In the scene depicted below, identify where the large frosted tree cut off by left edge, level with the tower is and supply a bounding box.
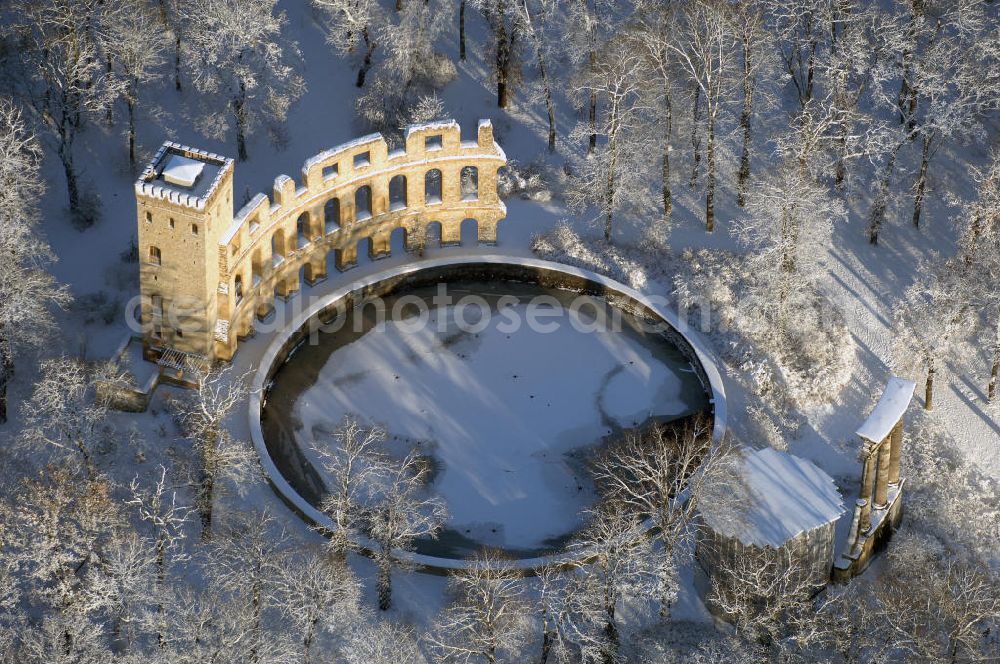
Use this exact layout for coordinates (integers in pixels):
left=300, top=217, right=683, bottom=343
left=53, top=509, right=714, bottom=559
left=0, top=99, right=70, bottom=424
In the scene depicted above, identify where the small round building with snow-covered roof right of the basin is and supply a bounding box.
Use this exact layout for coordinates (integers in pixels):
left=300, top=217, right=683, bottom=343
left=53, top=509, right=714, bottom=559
left=695, top=448, right=845, bottom=588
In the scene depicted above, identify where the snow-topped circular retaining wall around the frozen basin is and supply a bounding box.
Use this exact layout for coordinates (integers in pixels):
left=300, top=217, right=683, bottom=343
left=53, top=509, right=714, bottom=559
left=248, top=255, right=726, bottom=572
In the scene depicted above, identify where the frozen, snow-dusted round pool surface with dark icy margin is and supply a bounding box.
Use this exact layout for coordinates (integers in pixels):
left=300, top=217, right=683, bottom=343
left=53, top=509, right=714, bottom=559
left=260, top=274, right=710, bottom=558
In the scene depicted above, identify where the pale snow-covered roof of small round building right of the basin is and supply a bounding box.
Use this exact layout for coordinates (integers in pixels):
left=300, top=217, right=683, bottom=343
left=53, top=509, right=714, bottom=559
left=699, top=448, right=844, bottom=548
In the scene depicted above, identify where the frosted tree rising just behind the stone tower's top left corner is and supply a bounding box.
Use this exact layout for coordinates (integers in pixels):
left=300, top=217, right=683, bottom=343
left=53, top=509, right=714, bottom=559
left=102, top=0, right=167, bottom=168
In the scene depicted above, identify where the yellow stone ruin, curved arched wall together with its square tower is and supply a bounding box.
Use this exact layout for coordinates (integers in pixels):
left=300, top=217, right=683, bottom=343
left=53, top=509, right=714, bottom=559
left=135, top=120, right=506, bottom=362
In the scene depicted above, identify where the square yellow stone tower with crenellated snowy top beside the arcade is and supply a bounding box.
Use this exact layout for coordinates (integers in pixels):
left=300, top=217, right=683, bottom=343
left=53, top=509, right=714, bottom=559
left=135, top=142, right=233, bottom=371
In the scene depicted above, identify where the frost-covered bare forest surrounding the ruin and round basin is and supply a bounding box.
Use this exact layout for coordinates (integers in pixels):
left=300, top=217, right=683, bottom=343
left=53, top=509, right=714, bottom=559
left=0, top=0, right=1000, bottom=664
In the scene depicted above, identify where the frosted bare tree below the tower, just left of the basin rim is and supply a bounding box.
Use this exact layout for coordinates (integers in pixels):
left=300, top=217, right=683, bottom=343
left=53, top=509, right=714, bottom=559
left=174, top=367, right=257, bottom=540
